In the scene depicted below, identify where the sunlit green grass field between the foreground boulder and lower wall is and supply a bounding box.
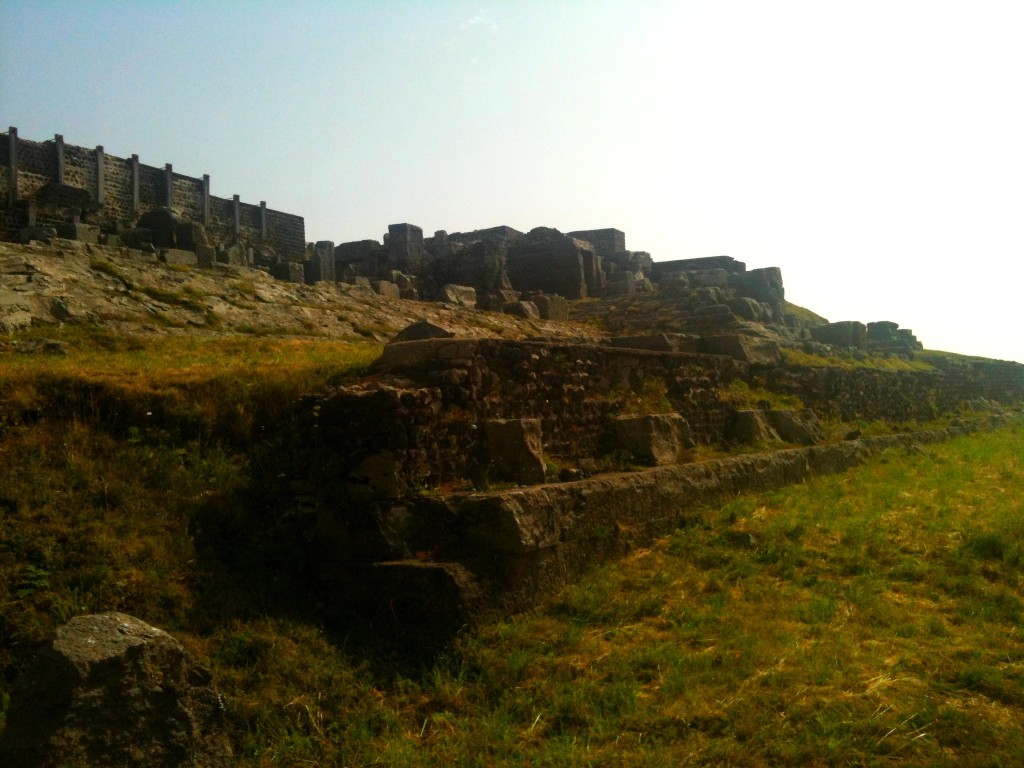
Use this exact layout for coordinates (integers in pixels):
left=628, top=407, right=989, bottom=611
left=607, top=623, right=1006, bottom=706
left=193, top=425, right=1024, bottom=766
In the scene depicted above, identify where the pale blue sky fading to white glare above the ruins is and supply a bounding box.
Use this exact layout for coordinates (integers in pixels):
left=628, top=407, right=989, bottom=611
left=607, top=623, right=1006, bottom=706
left=0, top=0, right=1024, bottom=361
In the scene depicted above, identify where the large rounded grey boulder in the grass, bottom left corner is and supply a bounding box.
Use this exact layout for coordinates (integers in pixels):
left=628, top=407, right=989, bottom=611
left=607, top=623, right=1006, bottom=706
left=0, top=613, right=231, bottom=768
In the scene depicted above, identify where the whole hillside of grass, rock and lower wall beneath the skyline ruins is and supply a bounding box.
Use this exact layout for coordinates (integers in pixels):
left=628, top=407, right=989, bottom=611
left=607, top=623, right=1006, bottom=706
left=0, top=240, right=1024, bottom=766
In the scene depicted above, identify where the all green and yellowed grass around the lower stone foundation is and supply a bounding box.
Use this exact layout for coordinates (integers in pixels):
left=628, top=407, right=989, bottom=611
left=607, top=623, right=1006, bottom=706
left=0, top=333, right=1024, bottom=766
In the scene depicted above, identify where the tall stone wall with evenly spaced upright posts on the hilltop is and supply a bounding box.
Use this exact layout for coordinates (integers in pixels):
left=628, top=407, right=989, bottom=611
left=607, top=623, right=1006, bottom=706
left=0, top=128, right=305, bottom=261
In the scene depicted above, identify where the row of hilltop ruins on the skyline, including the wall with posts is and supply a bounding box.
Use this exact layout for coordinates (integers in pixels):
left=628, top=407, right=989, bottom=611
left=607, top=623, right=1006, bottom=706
left=0, top=127, right=933, bottom=361
